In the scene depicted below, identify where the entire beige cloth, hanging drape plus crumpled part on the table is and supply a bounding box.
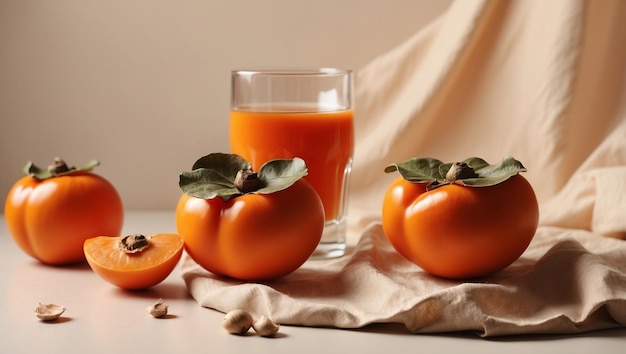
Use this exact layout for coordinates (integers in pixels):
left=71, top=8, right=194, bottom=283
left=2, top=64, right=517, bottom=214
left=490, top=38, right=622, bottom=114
left=181, top=0, right=626, bottom=336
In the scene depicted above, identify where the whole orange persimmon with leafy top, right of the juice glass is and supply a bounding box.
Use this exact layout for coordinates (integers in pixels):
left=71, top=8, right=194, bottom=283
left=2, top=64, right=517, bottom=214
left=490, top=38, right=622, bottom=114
left=382, top=157, right=539, bottom=279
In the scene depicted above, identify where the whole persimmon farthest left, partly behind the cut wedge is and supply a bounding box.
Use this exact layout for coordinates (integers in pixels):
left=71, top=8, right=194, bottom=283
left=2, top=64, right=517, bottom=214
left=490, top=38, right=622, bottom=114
left=4, top=158, right=124, bottom=265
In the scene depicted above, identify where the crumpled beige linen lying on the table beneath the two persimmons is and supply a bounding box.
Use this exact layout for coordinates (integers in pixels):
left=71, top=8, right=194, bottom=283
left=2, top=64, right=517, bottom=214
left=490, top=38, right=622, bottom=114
left=182, top=223, right=626, bottom=337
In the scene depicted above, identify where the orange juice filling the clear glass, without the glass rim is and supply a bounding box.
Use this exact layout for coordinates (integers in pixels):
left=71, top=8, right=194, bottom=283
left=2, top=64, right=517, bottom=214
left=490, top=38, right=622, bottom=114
left=230, top=110, right=354, bottom=220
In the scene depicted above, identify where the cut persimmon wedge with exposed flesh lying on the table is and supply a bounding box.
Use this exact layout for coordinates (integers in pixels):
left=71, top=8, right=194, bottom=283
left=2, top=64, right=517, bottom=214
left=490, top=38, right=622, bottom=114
left=83, top=234, right=183, bottom=290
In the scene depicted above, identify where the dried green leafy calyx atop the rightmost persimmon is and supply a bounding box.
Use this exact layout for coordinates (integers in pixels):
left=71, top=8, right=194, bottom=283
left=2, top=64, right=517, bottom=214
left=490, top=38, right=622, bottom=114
left=385, top=156, right=526, bottom=190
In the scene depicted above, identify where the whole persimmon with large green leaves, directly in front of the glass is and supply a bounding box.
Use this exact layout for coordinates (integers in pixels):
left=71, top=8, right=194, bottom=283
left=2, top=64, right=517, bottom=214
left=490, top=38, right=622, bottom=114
left=176, top=153, right=324, bottom=281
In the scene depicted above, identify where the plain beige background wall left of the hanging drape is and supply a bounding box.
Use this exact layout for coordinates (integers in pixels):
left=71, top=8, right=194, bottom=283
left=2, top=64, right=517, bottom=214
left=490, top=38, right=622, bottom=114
left=0, top=0, right=450, bottom=210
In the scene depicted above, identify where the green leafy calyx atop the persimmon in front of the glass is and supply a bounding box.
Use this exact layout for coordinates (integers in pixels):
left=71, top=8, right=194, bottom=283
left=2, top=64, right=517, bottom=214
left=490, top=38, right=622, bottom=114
left=178, top=153, right=308, bottom=201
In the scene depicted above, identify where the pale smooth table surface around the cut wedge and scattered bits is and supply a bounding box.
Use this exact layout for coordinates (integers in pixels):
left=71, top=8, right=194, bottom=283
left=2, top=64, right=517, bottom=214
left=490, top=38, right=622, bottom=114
left=0, top=211, right=626, bottom=354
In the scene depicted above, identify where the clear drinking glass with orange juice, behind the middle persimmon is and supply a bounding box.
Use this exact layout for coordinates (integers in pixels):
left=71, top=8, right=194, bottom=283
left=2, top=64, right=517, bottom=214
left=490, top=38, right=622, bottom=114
left=230, top=68, right=354, bottom=259
